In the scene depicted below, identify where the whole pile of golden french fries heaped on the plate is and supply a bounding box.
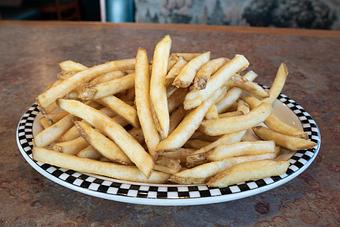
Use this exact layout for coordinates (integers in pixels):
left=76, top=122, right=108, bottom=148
left=33, top=35, right=316, bottom=187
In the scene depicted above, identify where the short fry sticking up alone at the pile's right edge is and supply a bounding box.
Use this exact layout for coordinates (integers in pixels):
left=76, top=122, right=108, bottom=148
left=268, top=63, right=288, bottom=103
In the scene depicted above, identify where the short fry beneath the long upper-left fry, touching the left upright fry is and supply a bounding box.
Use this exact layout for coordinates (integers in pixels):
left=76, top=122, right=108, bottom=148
left=79, top=73, right=135, bottom=100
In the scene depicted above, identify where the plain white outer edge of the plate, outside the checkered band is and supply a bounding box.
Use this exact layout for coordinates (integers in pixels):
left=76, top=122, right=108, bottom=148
left=16, top=94, right=321, bottom=206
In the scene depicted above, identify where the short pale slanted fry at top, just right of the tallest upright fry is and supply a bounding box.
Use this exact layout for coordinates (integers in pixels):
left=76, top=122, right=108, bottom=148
left=172, top=51, right=210, bottom=88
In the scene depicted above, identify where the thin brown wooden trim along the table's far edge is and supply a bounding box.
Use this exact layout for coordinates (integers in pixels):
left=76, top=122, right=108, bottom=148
left=0, top=20, right=340, bottom=38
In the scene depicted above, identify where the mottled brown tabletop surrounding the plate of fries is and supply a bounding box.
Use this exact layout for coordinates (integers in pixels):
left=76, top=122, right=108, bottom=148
left=0, top=21, right=340, bottom=226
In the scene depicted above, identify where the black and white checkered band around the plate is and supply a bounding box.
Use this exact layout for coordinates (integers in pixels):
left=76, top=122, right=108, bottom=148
left=17, top=94, right=320, bottom=199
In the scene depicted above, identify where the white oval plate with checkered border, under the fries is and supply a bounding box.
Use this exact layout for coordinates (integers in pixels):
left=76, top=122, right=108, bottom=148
left=16, top=94, right=321, bottom=206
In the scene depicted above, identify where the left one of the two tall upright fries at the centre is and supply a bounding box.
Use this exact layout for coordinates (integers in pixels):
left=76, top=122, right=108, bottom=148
left=135, top=48, right=160, bottom=154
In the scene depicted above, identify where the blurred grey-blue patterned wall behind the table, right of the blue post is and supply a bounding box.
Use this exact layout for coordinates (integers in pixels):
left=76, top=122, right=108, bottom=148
left=135, top=0, right=340, bottom=29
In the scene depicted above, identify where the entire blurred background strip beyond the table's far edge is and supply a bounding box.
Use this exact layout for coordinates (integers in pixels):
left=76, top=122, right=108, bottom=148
left=0, top=0, right=340, bottom=29
